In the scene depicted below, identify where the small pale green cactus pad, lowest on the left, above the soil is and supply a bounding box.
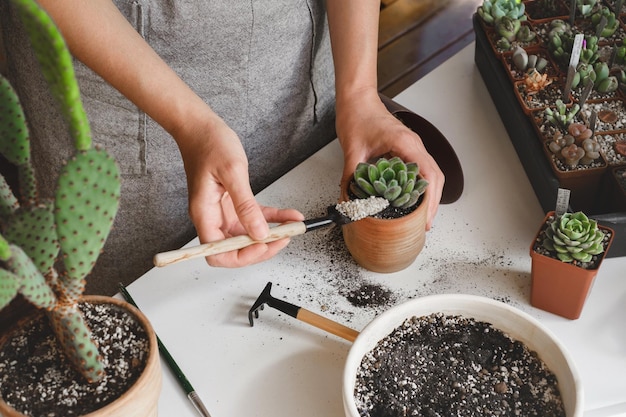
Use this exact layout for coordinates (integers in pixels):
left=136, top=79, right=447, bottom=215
left=7, top=245, right=56, bottom=309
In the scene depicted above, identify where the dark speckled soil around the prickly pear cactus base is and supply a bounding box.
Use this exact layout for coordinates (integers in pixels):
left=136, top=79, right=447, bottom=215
left=0, top=303, right=148, bottom=417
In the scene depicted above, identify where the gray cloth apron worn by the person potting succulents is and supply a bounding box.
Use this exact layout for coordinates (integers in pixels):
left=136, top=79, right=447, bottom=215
left=0, top=0, right=335, bottom=294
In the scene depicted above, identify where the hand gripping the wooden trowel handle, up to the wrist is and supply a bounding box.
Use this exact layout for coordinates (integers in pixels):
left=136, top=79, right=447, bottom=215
left=176, top=116, right=304, bottom=267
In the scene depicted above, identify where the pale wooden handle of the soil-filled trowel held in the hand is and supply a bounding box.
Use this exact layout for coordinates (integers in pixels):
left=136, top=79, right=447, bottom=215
left=153, top=222, right=307, bottom=266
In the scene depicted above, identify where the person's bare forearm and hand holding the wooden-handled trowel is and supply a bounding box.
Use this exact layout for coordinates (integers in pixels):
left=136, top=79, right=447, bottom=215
left=39, top=0, right=302, bottom=267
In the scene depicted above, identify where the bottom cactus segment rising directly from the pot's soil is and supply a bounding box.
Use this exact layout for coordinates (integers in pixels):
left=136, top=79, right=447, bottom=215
left=48, top=304, right=104, bottom=382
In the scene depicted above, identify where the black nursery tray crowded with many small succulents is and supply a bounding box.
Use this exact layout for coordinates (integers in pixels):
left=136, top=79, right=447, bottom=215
left=473, top=0, right=626, bottom=257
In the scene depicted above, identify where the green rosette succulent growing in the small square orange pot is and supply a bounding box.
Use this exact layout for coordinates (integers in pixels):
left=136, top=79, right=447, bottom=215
left=542, top=211, right=604, bottom=262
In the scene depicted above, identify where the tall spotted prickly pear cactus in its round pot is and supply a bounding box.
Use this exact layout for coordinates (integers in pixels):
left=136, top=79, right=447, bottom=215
left=0, top=0, right=161, bottom=416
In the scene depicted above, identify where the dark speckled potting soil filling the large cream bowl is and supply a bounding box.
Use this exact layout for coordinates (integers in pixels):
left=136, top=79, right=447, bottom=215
left=354, top=313, right=565, bottom=417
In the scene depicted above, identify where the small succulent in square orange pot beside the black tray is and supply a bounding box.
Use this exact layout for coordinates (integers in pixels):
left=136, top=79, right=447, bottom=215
left=530, top=211, right=615, bottom=320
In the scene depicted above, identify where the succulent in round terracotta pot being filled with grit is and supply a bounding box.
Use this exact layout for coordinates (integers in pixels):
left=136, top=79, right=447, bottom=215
left=341, top=157, right=428, bottom=273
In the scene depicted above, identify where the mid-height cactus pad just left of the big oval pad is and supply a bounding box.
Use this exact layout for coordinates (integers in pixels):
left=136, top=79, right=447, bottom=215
left=5, top=203, right=59, bottom=274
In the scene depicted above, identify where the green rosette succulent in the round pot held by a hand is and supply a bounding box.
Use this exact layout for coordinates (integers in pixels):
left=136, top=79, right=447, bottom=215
left=350, top=156, right=428, bottom=208
